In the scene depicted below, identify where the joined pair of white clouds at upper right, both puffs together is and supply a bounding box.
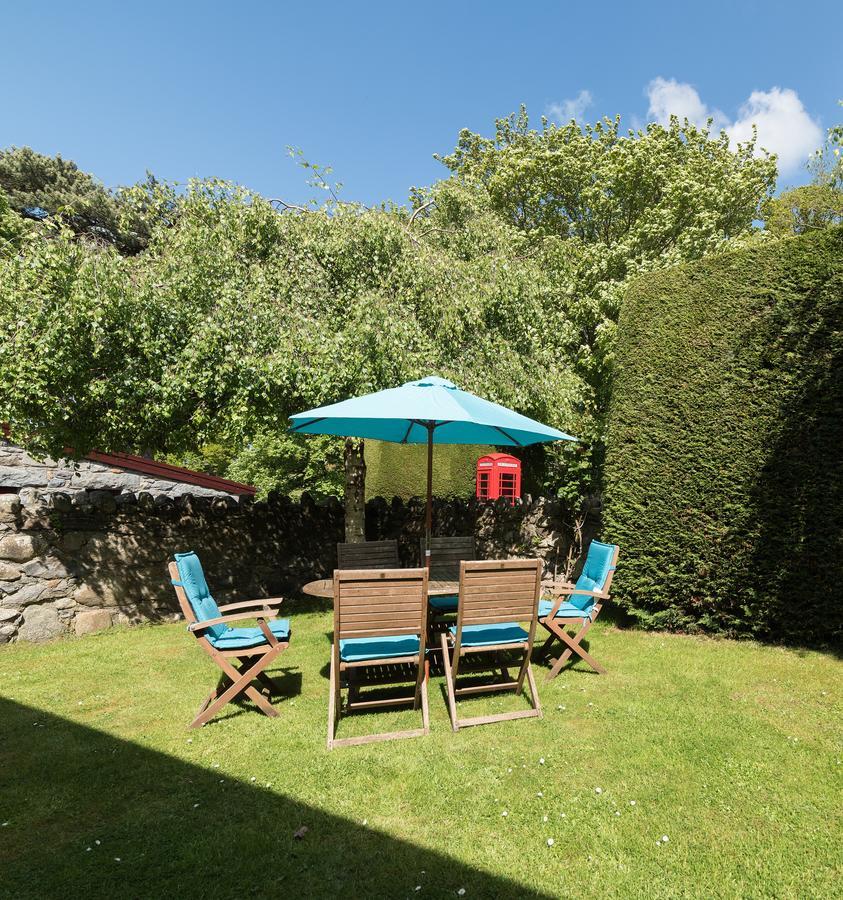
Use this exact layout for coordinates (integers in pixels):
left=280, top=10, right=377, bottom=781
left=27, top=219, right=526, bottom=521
left=646, top=78, right=823, bottom=173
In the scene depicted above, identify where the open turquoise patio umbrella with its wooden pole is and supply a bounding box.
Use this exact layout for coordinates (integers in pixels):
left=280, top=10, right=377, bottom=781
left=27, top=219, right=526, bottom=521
left=290, top=375, right=577, bottom=566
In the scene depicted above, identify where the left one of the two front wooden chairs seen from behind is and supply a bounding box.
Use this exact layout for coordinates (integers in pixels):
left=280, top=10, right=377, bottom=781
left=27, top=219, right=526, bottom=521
left=328, top=569, right=430, bottom=750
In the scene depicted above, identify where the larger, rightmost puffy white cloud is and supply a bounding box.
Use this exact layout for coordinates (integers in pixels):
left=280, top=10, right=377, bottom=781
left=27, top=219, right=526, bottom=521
left=726, top=88, right=823, bottom=172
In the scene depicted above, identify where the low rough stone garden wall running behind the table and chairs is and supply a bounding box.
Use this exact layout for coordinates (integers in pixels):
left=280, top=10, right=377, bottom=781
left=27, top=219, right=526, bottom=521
left=0, top=491, right=592, bottom=643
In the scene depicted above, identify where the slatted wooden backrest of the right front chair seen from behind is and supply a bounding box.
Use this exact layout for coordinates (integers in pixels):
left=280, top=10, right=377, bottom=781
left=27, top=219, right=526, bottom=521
left=457, top=559, right=541, bottom=630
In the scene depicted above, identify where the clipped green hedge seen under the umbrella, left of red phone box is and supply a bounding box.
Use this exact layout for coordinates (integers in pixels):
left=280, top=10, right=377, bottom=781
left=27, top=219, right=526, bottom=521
left=365, top=441, right=494, bottom=500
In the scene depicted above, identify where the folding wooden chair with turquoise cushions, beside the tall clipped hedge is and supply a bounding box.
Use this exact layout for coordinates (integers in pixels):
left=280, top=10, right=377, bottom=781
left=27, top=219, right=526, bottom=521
left=539, top=541, right=620, bottom=681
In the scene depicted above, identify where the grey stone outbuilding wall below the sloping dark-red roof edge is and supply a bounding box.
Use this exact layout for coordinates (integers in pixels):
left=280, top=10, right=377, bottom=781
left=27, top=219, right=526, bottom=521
left=0, top=440, right=244, bottom=497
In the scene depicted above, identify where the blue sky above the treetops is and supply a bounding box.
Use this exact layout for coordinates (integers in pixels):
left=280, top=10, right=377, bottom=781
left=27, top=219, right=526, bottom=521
left=0, top=0, right=843, bottom=204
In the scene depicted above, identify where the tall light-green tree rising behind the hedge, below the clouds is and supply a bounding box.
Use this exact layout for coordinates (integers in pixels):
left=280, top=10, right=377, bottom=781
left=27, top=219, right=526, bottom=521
left=441, top=107, right=776, bottom=430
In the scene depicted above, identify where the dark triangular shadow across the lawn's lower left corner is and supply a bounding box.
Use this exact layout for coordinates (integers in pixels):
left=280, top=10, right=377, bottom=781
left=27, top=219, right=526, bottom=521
left=0, top=699, right=545, bottom=898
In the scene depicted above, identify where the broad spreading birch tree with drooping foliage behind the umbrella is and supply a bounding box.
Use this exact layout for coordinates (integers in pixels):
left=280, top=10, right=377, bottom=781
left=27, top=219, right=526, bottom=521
left=0, top=181, right=581, bottom=536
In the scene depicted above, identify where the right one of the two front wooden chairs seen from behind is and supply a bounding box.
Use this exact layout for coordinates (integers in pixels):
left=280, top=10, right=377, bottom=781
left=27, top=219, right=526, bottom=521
left=441, top=559, right=542, bottom=731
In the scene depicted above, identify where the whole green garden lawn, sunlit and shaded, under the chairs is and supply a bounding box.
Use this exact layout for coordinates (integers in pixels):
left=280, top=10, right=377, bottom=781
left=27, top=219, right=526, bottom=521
left=0, top=602, right=843, bottom=898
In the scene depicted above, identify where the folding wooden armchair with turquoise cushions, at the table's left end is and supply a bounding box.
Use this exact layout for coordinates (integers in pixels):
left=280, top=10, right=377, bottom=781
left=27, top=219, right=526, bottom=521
left=168, top=553, right=290, bottom=728
